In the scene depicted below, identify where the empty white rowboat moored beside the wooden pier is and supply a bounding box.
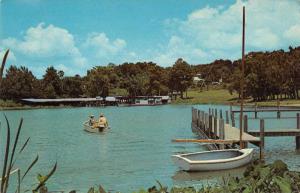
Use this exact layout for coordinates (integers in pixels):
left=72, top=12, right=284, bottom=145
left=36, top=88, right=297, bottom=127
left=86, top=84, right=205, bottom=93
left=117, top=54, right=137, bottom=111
left=172, top=148, right=253, bottom=171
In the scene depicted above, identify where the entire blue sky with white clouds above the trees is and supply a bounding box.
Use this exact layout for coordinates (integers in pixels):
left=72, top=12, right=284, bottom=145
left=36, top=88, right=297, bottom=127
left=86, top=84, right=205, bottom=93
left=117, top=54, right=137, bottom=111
left=0, top=0, right=300, bottom=77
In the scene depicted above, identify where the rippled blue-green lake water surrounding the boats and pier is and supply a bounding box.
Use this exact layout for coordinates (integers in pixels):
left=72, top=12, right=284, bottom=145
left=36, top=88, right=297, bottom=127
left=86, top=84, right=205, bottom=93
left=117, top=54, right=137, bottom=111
left=0, top=105, right=300, bottom=192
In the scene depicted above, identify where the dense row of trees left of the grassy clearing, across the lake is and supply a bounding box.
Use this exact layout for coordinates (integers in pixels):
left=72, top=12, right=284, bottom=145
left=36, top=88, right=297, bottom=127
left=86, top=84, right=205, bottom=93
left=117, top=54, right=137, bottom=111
left=0, top=59, right=192, bottom=100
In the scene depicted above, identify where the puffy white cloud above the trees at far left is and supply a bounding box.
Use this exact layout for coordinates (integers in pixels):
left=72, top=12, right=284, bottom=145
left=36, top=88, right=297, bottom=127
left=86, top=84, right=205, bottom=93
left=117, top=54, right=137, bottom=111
left=1, top=23, right=87, bottom=76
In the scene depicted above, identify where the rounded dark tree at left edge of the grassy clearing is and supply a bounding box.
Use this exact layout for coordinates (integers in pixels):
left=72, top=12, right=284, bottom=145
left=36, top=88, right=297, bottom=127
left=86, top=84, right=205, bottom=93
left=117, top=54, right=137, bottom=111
left=169, top=58, right=193, bottom=98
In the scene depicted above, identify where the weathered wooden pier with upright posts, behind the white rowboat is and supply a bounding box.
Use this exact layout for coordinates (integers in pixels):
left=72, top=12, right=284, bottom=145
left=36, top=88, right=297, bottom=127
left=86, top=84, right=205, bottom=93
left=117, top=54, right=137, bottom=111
left=191, top=108, right=300, bottom=159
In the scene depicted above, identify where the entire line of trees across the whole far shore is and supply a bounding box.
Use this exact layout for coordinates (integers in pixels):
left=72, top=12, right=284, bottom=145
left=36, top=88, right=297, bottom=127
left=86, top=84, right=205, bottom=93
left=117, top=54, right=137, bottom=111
left=0, top=47, right=300, bottom=101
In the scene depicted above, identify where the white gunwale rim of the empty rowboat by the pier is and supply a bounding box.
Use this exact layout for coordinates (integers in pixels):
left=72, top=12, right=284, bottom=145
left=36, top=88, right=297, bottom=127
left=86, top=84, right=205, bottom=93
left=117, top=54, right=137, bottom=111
left=172, top=148, right=254, bottom=164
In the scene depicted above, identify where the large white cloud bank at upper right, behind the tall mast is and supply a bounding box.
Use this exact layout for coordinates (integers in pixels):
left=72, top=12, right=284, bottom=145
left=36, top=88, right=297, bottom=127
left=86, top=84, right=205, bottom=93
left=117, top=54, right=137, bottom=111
left=154, top=0, right=300, bottom=65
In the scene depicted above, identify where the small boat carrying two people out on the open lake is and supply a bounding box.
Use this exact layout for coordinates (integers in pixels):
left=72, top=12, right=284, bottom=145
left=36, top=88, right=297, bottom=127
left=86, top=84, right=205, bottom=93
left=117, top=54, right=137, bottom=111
left=83, top=113, right=110, bottom=133
